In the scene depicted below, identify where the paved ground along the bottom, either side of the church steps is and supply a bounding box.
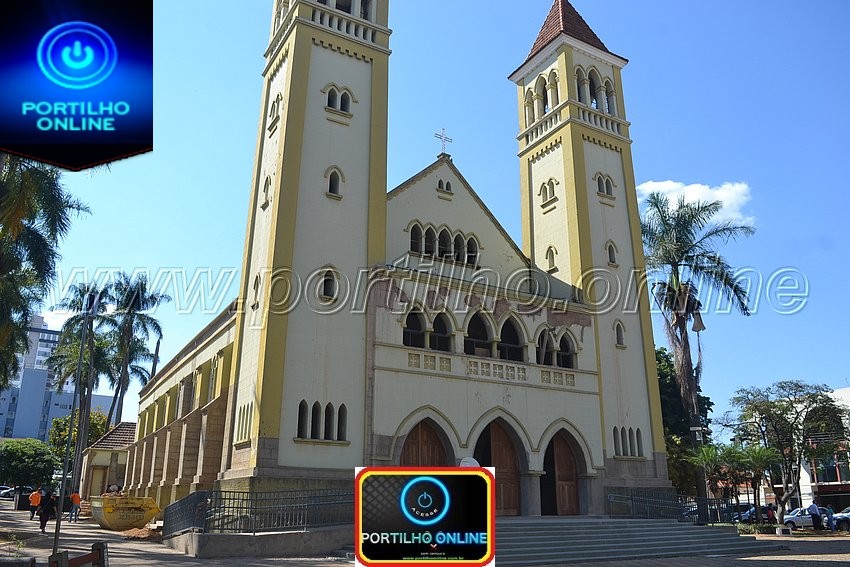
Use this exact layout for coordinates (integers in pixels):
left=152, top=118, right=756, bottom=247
left=0, top=500, right=850, bottom=567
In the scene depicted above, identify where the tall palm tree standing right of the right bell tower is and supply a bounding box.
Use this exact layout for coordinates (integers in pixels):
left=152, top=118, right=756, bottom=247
left=641, top=193, right=755, bottom=492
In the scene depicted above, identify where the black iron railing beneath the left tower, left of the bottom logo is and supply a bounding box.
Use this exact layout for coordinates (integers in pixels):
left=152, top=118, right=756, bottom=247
left=162, top=490, right=354, bottom=537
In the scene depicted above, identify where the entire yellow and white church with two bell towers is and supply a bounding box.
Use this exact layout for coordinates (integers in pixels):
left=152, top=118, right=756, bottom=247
left=125, top=0, right=670, bottom=515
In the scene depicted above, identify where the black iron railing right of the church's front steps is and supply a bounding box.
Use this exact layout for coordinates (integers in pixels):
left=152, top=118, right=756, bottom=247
left=608, top=489, right=734, bottom=524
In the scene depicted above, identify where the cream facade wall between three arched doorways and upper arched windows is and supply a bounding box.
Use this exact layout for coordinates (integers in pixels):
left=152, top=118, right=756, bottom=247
left=373, top=347, right=603, bottom=473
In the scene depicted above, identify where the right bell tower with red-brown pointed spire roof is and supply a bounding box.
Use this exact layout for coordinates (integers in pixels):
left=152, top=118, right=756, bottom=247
left=510, top=0, right=669, bottom=486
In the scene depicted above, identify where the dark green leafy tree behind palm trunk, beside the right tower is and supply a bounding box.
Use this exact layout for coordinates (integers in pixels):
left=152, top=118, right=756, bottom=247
left=655, top=347, right=714, bottom=495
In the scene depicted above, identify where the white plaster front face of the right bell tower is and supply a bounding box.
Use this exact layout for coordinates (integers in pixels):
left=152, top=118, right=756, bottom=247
left=584, top=142, right=652, bottom=456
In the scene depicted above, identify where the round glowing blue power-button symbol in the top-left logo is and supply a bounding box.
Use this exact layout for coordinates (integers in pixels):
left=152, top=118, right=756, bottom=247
left=37, top=22, right=118, bottom=90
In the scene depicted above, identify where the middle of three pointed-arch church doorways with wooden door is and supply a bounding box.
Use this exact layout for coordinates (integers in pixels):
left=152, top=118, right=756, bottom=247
left=474, top=420, right=520, bottom=516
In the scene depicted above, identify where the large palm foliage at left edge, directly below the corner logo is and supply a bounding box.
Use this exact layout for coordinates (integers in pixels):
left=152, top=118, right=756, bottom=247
left=0, top=153, right=88, bottom=388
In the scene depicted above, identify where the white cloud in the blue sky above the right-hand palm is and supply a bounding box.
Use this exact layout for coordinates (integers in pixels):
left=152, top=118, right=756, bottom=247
left=637, top=180, right=756, bottom=225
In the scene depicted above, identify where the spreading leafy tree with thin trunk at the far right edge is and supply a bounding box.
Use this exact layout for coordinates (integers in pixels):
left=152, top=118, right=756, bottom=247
left=730, top=380, right=847, bottom=523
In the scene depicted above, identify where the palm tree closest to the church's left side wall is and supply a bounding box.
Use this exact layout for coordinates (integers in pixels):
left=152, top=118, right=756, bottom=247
left=105, top=273, right=171, bottom=424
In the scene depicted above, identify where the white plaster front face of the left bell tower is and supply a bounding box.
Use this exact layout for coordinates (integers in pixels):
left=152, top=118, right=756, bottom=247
left=278, top=45, right=372, bottom=469
